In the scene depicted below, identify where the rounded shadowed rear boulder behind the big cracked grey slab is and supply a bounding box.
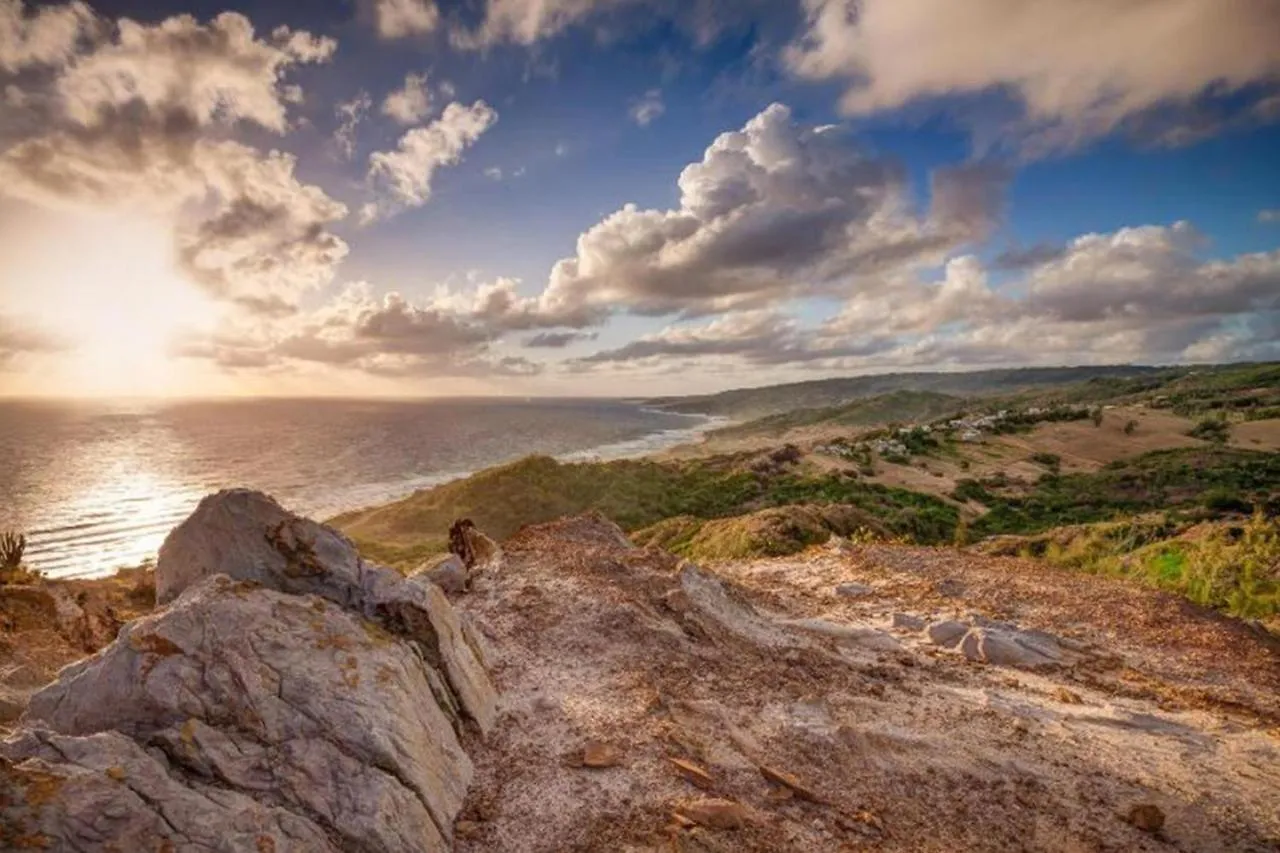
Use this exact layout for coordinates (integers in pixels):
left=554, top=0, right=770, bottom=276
left=156, top=489, right=497, bottom=731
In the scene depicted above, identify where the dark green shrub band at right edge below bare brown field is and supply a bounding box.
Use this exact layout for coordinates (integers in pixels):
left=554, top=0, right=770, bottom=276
left=952, top=447, right=1280, bottom=535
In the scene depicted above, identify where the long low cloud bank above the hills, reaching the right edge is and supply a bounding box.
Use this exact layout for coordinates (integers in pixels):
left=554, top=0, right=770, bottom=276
left=568, top=223, right=1280, bottom=371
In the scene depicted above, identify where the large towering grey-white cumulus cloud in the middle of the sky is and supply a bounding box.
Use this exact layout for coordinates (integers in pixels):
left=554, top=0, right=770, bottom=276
left=543, top=104, right=1007, bottom=315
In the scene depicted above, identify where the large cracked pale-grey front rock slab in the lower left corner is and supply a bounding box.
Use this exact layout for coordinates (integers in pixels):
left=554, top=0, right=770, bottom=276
left=0, top=576, right=472, bottom=852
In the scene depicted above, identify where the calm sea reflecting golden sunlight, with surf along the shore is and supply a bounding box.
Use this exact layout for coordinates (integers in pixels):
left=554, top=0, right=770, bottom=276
left=0, top=398, right=712, bottom=578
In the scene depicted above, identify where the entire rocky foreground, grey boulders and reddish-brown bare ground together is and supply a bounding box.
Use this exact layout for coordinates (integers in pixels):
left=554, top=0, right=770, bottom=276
left=0, top=492, right=1280, bottom=852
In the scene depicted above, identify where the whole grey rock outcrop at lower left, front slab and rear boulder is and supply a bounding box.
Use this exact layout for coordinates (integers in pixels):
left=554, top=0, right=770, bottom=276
left=0, top=491, right=497, bottom=852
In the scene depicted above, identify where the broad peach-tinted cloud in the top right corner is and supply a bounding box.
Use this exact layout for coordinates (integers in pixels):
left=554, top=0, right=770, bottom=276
left=785, top=0, right=1280, bottom=150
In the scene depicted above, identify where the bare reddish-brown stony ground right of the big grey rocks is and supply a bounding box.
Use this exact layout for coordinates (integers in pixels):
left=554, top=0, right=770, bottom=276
left=456, top=519, right=1280, bottom=853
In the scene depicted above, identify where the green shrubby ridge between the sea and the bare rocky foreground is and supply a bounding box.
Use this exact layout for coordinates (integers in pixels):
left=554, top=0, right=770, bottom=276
left=333, top=455, right=957, bottom=566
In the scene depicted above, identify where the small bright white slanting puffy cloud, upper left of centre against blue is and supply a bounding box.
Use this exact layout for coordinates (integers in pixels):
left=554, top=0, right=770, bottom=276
left=361, top=101, right=498, bottom=223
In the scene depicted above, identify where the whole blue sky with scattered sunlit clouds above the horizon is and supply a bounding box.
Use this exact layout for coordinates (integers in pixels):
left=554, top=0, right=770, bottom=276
left=0, top=0, right=1280, bottom=397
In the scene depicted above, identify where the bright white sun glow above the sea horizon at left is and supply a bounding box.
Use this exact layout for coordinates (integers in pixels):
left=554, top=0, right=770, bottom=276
left=27, top=218, right=215, bottom=396
